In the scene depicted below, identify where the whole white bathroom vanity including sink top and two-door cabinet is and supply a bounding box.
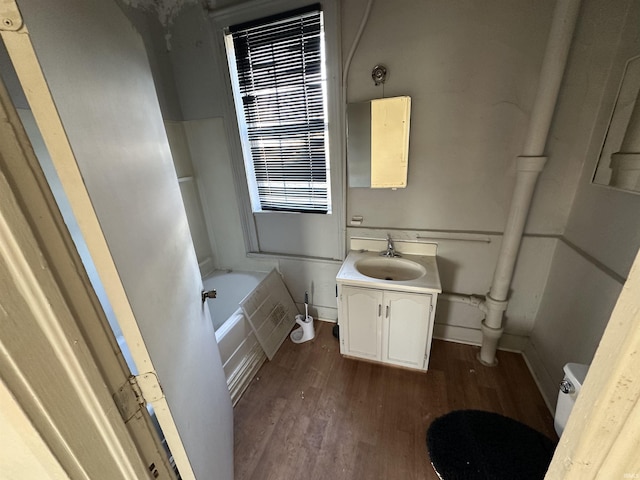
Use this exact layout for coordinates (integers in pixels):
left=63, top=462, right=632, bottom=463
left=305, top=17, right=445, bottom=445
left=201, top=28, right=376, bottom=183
left=336, top=246, right=442, bottom=371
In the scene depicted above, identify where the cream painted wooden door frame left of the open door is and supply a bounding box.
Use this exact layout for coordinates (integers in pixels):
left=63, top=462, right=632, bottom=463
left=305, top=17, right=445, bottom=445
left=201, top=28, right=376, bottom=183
left=0, top=66, right=175, bottom=479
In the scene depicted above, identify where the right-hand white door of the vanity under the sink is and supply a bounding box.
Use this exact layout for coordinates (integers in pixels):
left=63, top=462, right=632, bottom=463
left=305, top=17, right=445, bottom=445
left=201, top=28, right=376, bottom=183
left=382, top=292, right=432, bottom=370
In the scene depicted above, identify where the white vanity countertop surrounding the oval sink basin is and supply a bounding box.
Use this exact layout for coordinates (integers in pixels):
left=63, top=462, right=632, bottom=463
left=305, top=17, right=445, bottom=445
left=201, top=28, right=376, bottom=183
left=336, top=250, right=442, bottom=293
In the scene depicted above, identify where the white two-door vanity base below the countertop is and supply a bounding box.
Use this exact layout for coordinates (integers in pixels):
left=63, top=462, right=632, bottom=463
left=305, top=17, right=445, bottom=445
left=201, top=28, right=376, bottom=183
left=338, top=283, right=437, bottom=371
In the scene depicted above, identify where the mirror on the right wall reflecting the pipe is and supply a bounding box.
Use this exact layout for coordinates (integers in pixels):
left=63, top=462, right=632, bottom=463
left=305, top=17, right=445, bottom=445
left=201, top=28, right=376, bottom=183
left=593, top=55, right=640, bottom=193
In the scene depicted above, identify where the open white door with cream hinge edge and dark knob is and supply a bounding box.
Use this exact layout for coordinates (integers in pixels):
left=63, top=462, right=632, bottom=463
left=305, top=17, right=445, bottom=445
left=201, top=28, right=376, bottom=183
left=2, top=0, right=233, bottom=480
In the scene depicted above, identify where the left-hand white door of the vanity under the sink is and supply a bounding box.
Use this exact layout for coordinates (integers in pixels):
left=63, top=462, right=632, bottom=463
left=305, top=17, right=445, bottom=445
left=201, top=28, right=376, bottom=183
left=340, top=286, right=382, bottom=360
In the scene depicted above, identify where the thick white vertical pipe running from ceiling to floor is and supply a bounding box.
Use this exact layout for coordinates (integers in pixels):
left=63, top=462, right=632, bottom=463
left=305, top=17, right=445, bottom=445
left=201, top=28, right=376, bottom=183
left=479, top=0, right=580, bottom=365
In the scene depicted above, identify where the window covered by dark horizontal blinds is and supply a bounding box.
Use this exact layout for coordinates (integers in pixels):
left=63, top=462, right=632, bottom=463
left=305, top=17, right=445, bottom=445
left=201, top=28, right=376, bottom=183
left=225, top=5, right=331, bottom=213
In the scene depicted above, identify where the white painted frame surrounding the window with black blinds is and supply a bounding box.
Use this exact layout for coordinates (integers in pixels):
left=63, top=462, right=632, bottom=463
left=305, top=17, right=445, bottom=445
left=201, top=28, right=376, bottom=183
left=210, top=0, right=345, bottom=260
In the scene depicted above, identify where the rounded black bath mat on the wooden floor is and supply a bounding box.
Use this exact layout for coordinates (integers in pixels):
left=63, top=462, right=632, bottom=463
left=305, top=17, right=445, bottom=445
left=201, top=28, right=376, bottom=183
left=427, top=410, right=555, bottom=480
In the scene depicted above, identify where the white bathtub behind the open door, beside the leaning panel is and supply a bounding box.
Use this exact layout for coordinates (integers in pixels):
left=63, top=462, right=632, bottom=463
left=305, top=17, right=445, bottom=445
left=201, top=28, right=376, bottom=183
left=203, top=270, right=267, bottom=405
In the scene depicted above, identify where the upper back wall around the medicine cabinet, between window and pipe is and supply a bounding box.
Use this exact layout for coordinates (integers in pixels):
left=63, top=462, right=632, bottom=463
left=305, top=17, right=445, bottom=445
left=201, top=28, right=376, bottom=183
left=342, top=0, right=556, bottom=233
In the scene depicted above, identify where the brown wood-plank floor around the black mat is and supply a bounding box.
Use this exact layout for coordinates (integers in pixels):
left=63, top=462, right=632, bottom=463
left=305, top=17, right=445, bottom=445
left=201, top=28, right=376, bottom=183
left=234, top=322, right=557, bottom=480
